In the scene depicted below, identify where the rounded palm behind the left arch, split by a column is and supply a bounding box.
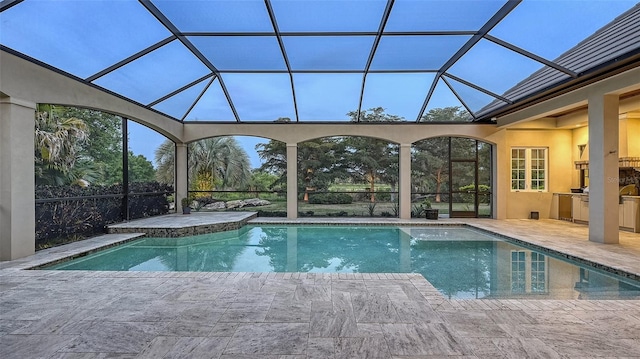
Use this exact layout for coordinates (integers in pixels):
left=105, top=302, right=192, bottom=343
left=155, top=137, right=251, bottom=191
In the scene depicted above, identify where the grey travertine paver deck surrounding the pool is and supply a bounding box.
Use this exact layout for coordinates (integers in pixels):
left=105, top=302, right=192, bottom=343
left=0, top=216, right=640, bottom=359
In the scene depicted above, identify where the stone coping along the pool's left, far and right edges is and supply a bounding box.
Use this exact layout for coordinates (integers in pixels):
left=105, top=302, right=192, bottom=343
left=6, top=217, right=640, bottom=282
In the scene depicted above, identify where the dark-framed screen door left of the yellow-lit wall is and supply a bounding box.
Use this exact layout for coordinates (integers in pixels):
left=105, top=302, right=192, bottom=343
left=449, top=160, right=478, bottom=218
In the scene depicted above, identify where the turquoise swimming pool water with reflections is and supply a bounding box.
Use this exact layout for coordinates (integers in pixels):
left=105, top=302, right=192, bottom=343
left=47, top=225, right=640, bottom=299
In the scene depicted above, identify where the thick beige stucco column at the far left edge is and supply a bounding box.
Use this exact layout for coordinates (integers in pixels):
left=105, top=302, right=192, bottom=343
left=0, top=95, right=36, bottom=260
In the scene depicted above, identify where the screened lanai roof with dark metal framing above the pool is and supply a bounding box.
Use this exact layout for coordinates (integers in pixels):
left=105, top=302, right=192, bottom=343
left=0, top=0, right=640, bottom=122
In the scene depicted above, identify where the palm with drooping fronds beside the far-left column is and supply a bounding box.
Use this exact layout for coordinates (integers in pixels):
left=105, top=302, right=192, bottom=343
left=34, top=105, right=96, bottom=185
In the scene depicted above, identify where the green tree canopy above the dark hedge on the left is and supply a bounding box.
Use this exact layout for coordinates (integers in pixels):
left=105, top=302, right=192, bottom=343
left=35, top=105, right=160, bottom=185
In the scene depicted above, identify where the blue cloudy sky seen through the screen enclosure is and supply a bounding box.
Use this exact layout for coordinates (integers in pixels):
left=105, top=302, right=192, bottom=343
left=0, top=0, right=638, bottom=167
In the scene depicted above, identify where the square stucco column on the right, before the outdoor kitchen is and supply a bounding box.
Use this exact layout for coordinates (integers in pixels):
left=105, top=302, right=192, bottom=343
left=588, top=94, right=619, bottom=243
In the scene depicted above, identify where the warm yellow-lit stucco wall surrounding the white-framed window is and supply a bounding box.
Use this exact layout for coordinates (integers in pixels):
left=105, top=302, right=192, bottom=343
left=498, top=130, right=574, bottom=218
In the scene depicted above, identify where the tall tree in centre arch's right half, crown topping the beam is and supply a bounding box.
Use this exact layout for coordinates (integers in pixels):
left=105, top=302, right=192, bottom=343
left=345, top=107, right=404, bottom=202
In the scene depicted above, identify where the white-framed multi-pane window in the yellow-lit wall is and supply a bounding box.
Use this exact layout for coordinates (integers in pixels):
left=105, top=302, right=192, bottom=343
left=511, top=148, right=547, bottom=192
